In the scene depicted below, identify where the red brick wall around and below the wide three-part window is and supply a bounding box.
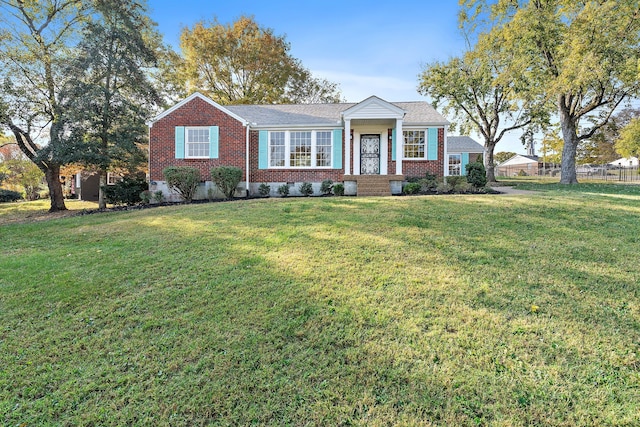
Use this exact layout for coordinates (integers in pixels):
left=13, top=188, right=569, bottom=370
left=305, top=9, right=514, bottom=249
left=249, top=130, right=344, bottom=183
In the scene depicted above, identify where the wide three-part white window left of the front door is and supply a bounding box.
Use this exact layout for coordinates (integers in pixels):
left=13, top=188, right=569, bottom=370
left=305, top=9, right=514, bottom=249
left=268, top=130, right=333, bottom=168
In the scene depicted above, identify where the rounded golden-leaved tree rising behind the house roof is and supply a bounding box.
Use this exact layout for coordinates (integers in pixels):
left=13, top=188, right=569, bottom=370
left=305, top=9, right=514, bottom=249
left=174, top=16, right=340, bottom=104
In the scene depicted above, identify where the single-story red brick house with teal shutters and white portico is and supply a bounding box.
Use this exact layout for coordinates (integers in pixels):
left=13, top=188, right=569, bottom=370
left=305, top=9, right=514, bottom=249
left=149, top=93, right=462, bottom=200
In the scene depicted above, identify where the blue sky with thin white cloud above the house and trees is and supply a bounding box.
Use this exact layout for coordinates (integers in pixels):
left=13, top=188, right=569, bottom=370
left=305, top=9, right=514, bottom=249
left=148, top=0, right=524, bottom=152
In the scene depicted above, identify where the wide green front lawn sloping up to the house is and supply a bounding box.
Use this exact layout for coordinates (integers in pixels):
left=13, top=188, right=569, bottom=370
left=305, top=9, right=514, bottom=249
left=0, top=191, right=640, bottom=426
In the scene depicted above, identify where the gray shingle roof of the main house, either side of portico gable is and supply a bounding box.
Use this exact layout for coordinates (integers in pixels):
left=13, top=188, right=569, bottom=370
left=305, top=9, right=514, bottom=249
left=225, top=101, right=448, bottom=126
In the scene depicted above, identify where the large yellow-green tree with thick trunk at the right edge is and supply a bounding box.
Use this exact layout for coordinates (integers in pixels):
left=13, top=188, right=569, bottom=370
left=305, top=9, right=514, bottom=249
left=463, top=0, right=640, bottom=184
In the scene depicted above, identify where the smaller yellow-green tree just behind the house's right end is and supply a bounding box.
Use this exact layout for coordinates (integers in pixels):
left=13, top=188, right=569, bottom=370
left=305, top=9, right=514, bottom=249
left=418, top=30, right=545, bottom=183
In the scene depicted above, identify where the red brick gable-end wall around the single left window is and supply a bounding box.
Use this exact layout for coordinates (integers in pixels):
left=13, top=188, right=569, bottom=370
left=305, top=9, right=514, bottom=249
left=149, top=98, right=246, bottom=181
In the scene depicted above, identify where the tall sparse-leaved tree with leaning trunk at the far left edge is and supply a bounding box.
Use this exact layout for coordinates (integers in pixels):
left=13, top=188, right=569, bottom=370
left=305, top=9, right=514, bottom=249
left=0, top=0, right=89, bottom=212
